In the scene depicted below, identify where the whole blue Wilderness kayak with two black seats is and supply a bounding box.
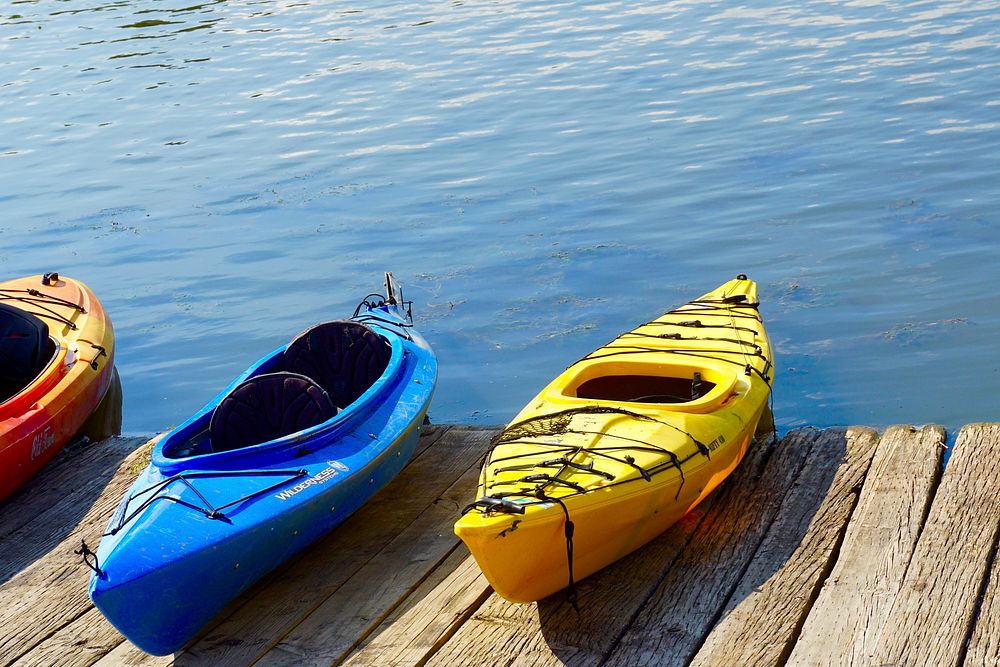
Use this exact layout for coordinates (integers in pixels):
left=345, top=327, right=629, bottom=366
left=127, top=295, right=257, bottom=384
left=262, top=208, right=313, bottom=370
left=89, top=274, right=437, bottom=655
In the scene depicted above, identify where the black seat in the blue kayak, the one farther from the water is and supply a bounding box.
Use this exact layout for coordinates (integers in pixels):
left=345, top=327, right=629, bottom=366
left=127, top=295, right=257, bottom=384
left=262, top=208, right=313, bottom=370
left=208, top=372, right=337, bottom=452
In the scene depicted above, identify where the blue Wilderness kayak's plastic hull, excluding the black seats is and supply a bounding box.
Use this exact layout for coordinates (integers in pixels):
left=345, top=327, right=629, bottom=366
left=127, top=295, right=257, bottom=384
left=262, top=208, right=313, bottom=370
left=90, top=306, right=437, bottom=655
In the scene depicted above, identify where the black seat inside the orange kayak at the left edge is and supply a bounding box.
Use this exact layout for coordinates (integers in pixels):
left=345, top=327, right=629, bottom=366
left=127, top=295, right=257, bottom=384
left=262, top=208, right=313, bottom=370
left=0, top=303, right=53, bottom=401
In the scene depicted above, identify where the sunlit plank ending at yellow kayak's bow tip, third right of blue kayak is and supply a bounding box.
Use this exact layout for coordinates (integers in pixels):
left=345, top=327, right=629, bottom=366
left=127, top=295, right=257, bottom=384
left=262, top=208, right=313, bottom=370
left=344, top=545, right=493, bottom=667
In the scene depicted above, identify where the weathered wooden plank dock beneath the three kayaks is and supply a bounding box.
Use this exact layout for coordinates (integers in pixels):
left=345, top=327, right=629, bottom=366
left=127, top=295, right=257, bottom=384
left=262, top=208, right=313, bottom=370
left=0, top=424, right=1000, bottom=667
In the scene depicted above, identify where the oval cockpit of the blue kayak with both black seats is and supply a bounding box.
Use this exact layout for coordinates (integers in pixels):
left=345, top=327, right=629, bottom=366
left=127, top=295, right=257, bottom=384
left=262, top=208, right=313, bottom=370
left=153, top=320, right=403, bottom=468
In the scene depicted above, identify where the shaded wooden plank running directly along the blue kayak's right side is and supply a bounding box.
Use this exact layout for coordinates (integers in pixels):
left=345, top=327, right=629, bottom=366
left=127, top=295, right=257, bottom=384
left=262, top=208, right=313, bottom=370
left=111, top=426, right=493, bottom=666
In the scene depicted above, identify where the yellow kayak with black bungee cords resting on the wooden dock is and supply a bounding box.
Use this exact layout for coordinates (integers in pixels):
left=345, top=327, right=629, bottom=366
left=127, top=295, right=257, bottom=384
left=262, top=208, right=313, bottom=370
left=455, top=275, right=774, bottom=602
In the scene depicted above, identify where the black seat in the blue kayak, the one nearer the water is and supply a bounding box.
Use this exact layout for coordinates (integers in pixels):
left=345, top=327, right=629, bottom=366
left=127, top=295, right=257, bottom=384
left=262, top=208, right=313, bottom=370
left=282, top=320, right=392, bottom=409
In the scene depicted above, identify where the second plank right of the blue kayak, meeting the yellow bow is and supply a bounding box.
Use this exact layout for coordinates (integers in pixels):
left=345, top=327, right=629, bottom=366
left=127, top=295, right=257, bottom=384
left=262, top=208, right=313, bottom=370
left=262, top=452, right=487, bottom=666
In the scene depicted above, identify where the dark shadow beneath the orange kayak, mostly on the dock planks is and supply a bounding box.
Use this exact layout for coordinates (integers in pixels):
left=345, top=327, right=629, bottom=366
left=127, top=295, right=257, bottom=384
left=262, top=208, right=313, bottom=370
left=0, top=368, right=129, bottom=584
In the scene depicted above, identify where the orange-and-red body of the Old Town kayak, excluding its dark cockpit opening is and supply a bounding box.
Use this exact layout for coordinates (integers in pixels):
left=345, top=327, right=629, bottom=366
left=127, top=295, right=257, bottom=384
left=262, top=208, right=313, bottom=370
left=0, top=276, right=115, bottom=501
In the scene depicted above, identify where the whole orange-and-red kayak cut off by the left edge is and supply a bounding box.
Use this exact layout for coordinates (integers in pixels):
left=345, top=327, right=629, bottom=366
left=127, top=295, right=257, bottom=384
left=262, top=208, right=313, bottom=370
left=0, top=274, right=114, bottom=500
